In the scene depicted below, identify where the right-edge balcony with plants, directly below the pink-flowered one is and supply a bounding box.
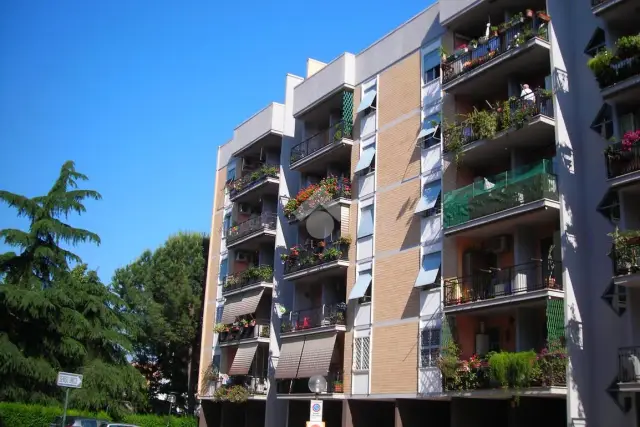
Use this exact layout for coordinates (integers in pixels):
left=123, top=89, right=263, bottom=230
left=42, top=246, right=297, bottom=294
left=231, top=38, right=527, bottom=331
left=610, top=229, right=640, bottom=287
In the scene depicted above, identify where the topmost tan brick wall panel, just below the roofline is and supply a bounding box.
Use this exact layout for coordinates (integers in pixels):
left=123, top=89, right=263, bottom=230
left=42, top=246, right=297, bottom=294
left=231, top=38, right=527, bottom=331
left=378, top=52, right=422, bottom=128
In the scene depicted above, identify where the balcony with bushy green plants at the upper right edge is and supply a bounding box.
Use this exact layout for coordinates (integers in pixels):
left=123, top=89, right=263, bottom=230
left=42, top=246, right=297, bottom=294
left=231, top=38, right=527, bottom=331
left=587, top=34, right=640, bottom=102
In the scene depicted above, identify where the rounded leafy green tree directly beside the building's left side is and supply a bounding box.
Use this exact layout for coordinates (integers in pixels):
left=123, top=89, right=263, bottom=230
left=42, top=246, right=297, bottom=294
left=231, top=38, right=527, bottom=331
left=111, top=233, right=209, bottom=413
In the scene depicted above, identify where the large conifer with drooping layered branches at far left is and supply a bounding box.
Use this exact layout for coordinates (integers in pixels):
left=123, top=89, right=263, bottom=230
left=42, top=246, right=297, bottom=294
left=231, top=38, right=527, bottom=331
left=0, top=162, right=146, bottom=418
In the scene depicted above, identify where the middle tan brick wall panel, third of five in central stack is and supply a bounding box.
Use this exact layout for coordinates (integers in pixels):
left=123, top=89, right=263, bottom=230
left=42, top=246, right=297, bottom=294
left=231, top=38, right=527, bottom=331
left=374, top=178, right=420, bottom=255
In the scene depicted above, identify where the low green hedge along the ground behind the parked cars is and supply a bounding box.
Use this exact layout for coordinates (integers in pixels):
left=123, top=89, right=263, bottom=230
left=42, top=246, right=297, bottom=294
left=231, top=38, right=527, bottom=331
left=0, top=402, right=198, bottom=427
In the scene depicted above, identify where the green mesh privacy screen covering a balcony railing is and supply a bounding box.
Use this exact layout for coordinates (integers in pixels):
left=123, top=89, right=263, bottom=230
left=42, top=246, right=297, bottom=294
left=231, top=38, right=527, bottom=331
left=443, top=159, right=558, bottom=228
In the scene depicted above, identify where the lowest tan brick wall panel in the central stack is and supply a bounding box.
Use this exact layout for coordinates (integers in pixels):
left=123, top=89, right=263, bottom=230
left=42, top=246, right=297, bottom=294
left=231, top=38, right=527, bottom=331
left=371, top=319, right=418, bottom=394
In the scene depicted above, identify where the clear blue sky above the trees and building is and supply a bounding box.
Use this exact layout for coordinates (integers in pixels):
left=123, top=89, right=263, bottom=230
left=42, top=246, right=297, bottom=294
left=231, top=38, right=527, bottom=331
left=0, top=0, right=431, bottom=281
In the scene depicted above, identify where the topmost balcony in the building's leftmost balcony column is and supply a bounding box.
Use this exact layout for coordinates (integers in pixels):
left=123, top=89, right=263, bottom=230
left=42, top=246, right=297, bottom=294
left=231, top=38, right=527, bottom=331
left=227, top=165, right=280, bottom=203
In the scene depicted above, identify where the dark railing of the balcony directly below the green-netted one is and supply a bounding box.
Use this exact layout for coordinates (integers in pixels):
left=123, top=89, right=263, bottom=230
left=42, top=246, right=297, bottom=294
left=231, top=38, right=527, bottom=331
left=444, top=260, right=563, bottom=306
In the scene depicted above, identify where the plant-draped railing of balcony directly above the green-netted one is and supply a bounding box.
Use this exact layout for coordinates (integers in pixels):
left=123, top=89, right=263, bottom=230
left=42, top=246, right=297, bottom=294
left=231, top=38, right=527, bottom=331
left=444, top=88, right=554, bottom=152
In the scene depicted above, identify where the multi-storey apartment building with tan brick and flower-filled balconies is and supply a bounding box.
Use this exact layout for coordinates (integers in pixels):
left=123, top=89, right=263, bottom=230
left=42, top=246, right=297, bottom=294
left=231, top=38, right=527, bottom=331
left=199, top=0, right=640, bottom=427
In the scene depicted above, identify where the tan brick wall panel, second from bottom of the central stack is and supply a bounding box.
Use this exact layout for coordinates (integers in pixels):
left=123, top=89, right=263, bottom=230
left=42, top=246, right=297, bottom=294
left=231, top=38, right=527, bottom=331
left=372, top=248, right=420, bottom=323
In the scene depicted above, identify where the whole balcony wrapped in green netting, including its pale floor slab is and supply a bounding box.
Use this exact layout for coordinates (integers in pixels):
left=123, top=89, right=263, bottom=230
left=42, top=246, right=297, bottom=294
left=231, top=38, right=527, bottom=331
left=443, top=160, right=560, bottom=235
